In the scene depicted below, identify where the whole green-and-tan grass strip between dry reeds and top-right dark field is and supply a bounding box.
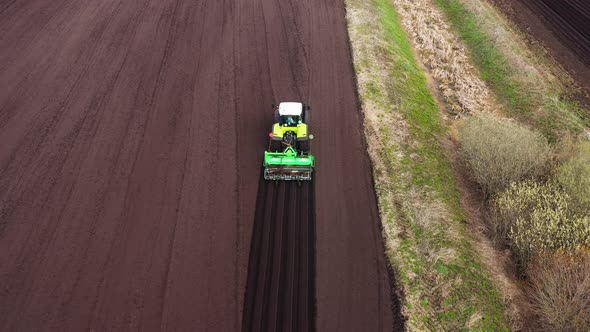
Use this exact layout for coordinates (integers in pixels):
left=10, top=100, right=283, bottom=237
left=432, top=0, right=590, bottom=142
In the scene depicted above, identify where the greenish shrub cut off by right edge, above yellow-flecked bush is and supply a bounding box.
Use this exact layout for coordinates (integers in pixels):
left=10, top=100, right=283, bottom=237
left=557, top=142, right=590, bottom=213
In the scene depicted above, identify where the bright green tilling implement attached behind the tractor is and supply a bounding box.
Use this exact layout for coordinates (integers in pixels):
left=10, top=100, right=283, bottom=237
left=263, top=146, right=315, bottom=181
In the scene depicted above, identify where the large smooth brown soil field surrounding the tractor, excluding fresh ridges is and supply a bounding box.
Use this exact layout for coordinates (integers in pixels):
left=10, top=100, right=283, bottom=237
left=0, top=0, right=394, bottom=331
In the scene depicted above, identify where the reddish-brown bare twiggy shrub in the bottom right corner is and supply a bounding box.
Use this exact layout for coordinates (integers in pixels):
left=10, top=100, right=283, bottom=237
left=527, top=253, right=590, bottom=331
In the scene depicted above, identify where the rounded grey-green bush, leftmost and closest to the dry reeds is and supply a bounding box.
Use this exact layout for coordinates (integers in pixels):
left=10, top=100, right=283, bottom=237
left=459, top=116, right=551, bottom=194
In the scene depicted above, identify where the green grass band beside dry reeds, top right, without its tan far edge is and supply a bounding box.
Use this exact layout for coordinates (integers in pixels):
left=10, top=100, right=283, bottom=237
left=435, top=0, right=590, bottom=142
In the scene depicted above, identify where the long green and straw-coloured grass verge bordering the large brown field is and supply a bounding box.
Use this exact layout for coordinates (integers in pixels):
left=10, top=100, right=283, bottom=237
left=347, top=0, right=508, bottom=331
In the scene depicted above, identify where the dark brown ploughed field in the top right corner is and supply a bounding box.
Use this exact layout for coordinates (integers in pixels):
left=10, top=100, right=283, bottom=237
left=489, top=0, right=590, bottom=92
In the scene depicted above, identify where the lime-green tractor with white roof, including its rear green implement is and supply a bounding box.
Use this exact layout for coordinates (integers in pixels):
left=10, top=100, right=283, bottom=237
left=263, top=102, right=315, bottom=181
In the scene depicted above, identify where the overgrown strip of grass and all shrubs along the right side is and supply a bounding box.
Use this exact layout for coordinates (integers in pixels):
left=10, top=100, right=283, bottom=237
left=430, top=0, right=590, bottom=331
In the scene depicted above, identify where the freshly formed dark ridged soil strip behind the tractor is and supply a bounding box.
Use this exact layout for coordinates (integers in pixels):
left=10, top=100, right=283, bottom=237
left=242, top=176, right=315, bottom=332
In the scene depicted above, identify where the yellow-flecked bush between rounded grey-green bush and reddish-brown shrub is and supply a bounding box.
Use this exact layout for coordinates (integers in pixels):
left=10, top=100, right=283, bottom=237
left=493, top=180, right=590, bottom=266
